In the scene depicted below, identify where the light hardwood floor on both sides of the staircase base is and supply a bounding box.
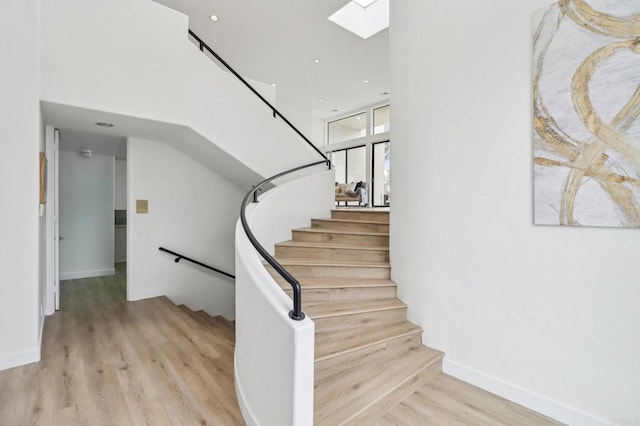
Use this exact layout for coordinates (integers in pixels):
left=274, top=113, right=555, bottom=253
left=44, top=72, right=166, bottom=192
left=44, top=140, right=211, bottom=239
left=0, top=265, right=556, bottom=426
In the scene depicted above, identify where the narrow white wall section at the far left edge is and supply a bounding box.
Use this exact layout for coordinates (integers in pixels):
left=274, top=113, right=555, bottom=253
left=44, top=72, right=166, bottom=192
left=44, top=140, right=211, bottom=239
left=0, top=0, right=42, bottom=370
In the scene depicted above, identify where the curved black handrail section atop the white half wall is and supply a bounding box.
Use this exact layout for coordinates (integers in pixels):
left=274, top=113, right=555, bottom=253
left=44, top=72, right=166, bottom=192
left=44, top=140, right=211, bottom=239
left=240, top=159, right=331, bottom=321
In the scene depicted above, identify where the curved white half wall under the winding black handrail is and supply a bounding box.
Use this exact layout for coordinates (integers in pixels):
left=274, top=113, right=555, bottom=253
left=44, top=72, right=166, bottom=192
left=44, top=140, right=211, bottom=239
left=235, top=170, right=334, bottom=426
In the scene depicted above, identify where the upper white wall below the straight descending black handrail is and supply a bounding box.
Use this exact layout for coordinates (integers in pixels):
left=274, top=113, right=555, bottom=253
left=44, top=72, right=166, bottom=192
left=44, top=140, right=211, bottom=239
left=42, top=0, right=318, bottom=183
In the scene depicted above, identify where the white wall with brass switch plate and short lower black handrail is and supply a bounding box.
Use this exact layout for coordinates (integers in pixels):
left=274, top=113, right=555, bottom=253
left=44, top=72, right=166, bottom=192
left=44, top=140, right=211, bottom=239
left=127, top=138, right=244, bottom=319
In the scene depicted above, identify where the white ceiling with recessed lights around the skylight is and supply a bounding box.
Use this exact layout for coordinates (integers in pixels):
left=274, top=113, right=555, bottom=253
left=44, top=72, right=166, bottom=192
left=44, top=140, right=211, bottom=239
left=155, top=0, right=389, bottom=119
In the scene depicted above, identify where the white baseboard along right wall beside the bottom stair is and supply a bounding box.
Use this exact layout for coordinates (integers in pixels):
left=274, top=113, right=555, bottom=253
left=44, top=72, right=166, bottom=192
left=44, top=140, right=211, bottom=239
left=442, top=357, right=613, bottom=426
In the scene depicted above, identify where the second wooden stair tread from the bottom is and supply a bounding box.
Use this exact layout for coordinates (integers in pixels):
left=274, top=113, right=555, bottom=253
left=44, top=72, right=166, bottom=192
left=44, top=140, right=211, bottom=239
left=315, top=321, right=422, bottom=362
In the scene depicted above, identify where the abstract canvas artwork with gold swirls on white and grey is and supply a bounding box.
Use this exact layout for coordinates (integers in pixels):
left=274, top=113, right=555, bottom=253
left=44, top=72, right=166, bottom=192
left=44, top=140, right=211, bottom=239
left=533, top=0, right=640, bottom=228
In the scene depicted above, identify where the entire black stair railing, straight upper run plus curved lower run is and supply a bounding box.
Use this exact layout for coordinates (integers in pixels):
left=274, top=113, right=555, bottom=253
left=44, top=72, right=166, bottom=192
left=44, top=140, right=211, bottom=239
left=189, top=30, right=331, bottom=321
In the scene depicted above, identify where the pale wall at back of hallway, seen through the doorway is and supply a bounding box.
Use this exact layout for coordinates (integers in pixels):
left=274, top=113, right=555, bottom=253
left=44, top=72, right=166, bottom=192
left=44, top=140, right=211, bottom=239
left=59, top=151, right=115, bottom=280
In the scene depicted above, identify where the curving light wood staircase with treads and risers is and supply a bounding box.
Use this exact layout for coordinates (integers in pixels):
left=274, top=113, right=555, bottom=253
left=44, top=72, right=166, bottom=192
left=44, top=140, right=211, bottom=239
left=266, top=210, right=443, bottom=425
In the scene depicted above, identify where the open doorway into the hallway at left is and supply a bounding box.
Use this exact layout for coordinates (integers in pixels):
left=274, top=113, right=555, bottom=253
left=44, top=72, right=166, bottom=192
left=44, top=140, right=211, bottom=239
left=45, top=126, right=127, bottom=315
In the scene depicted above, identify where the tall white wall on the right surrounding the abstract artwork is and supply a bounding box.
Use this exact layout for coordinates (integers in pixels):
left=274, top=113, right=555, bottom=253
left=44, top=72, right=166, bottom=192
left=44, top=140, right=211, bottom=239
left=390, top=0, right=640, bottom=425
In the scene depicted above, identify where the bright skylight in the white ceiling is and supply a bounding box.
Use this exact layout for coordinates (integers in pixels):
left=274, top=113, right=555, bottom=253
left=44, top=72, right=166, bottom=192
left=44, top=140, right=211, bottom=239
left=329, top=0, right=389, bottom=40
